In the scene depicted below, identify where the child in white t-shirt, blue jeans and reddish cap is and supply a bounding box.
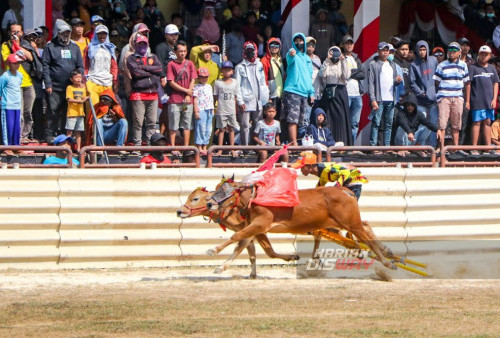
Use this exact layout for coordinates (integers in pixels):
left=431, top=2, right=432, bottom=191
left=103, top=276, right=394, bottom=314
left=193, top=67, right=214, bottom=155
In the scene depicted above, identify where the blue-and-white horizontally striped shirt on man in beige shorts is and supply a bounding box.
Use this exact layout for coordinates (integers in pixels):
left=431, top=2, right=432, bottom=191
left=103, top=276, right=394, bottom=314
left=433, top=60, right=470, bottom=101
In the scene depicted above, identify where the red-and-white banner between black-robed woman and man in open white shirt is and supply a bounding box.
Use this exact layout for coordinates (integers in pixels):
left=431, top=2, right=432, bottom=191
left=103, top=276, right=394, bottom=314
left=353, top=0, right=380, bottom=144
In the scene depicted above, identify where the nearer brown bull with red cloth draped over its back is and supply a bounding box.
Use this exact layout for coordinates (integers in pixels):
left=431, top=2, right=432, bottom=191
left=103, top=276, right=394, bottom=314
left=207, top=180, right=394, bottom=268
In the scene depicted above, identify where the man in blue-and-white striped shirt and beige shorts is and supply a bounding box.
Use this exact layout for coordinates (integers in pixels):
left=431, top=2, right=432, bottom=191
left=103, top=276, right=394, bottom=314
left=434, top=42, right=470, bottom=149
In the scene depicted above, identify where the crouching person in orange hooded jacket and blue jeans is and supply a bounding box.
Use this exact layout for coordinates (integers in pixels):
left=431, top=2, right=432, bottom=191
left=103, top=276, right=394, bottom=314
left=86, top=89, right=128, bottom=150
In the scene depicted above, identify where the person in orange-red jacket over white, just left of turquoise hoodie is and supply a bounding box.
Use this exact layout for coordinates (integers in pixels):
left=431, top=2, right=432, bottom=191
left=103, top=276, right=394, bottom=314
left=261, top=38, right=285, bottom=121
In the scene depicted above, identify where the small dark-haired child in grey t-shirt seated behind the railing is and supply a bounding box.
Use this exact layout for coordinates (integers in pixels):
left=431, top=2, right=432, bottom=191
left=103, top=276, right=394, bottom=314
left=253, top=102, right=288, bottom=162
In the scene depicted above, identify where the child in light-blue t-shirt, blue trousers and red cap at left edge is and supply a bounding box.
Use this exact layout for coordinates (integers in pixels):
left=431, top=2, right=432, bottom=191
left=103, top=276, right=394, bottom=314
left=0, top=54, right=23, bottom=155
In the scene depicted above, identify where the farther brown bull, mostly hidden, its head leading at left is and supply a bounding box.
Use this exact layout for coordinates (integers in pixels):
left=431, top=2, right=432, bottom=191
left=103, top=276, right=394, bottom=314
left=177, top=188, right=299, bottom=278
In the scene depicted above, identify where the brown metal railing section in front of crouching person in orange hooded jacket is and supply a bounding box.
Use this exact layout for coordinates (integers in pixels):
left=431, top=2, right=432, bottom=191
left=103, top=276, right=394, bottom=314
left=79, top=146, right=200, bottom=168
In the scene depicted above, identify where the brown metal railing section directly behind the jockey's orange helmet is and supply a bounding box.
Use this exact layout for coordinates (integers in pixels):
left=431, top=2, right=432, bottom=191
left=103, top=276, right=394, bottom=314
left=206, top=145, right=322, bottom=168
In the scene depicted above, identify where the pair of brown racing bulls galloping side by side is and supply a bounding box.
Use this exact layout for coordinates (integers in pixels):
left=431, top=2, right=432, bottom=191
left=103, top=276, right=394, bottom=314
left=177, top=158, right=426, bottom=278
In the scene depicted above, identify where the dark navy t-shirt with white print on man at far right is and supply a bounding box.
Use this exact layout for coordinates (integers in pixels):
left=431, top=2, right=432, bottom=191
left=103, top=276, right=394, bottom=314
left=469, top=64, right=498, bottom=110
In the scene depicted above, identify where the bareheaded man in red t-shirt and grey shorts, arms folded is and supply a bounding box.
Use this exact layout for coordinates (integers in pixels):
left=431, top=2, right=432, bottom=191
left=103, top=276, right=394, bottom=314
left=167, top=41, right=198, bottom=146
